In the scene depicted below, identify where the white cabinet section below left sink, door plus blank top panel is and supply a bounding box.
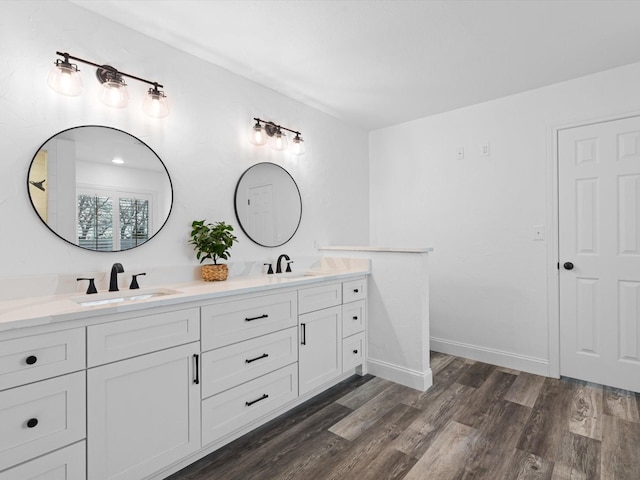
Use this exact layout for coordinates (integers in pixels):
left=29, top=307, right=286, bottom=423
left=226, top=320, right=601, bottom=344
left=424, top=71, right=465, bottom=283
left=87, top=308, right=200, bottom=480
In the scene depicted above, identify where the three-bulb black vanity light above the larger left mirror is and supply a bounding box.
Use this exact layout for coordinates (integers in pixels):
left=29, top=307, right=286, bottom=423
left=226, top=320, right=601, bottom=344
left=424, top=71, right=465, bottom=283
left=47, top=52, right=169, bottom=118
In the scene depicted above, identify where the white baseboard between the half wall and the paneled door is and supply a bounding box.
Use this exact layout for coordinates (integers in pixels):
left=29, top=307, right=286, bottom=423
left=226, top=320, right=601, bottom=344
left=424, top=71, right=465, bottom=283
left=431, top=337, right=550, bottom=377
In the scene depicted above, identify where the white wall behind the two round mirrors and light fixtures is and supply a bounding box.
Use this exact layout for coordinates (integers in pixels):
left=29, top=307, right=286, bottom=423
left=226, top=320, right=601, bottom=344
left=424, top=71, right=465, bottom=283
left=0, top=1, right=369, bottom=280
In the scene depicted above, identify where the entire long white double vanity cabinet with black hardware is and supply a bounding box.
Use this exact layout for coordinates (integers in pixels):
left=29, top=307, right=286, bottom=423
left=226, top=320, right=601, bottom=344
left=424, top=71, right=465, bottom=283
left=0, top=268, right=366, bottom=480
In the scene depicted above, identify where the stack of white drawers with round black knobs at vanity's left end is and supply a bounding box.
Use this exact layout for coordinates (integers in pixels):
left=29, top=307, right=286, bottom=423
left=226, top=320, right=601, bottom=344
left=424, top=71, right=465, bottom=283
left=0, top=328, right=86, bottom=480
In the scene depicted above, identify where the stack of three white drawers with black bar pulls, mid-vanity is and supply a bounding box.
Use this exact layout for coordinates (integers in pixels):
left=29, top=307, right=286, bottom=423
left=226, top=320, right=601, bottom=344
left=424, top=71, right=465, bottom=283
left=202, top=290, right=298, bottom=445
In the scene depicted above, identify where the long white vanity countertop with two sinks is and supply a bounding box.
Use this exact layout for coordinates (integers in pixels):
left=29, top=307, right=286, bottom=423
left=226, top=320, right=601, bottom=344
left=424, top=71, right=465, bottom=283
left=0, top=265, right=370, bottom=332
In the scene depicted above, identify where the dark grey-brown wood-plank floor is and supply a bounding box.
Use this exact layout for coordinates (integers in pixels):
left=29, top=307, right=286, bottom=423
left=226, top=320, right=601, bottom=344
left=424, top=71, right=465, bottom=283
left=169, top=353, right=640, bottom=480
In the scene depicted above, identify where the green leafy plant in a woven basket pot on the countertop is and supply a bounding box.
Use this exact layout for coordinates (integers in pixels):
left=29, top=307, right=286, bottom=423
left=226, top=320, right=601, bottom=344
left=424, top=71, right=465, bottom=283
left=189, top=220, right=238, bottom=282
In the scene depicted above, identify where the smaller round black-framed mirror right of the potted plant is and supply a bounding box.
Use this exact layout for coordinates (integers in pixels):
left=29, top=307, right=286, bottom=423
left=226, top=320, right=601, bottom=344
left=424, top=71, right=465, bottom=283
left=235, top=162, right=302, bottom=247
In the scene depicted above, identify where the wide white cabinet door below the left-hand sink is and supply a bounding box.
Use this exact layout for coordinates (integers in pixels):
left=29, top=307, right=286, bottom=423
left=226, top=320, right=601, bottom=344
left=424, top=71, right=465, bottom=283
left=87, top=343, right=200, bottom=480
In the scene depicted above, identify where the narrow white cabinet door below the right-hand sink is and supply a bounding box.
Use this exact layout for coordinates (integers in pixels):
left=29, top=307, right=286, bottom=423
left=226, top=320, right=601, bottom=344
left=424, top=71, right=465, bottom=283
left=298, top=305, right=342, bottom=395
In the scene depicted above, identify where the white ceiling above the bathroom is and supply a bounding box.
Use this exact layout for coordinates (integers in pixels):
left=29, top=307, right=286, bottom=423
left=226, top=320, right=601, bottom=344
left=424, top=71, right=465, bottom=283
left=72, top=0, right=640, bottom=130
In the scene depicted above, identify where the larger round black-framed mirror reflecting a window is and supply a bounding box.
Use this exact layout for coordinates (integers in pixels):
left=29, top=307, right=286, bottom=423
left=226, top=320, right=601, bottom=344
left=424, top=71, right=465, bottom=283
left=27, top=125, right=173, bottom=252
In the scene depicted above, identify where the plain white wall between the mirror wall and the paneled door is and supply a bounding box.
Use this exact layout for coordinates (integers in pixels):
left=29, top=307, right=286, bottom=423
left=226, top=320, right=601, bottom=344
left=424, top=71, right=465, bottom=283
left=369, top=64, right=640, bottom=373
